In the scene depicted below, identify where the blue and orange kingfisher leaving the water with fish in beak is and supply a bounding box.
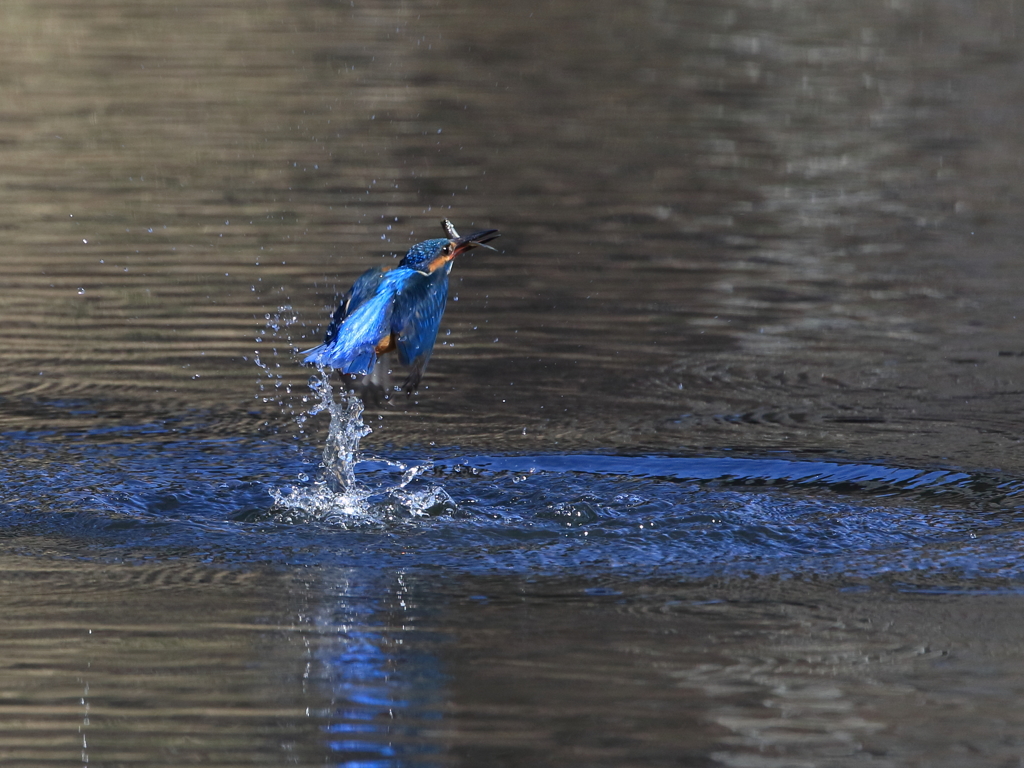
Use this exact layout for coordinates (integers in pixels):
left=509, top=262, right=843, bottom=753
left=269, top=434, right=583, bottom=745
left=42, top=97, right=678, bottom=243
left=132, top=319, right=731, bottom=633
left=303, top=219, right=499, bottom=394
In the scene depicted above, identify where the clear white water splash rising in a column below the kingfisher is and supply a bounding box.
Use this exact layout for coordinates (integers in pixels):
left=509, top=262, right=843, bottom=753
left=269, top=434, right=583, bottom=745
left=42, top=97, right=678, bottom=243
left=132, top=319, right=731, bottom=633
left=270, top=369, right=455, bottom=526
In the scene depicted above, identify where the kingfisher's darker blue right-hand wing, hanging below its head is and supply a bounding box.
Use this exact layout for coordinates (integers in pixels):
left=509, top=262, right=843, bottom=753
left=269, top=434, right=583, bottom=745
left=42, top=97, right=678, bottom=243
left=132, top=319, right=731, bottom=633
left=391, top=268, right=449, bottom=392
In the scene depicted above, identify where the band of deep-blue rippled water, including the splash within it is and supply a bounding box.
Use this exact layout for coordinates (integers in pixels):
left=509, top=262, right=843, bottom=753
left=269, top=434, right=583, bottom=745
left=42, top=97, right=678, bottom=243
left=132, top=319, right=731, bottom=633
left=3, top=400, right=1024, bottom=581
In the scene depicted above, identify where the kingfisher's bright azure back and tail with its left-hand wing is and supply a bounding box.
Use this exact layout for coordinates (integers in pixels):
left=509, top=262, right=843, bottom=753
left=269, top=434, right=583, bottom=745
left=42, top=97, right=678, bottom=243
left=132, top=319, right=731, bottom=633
left=303, top=269, right=397, bottom=374
